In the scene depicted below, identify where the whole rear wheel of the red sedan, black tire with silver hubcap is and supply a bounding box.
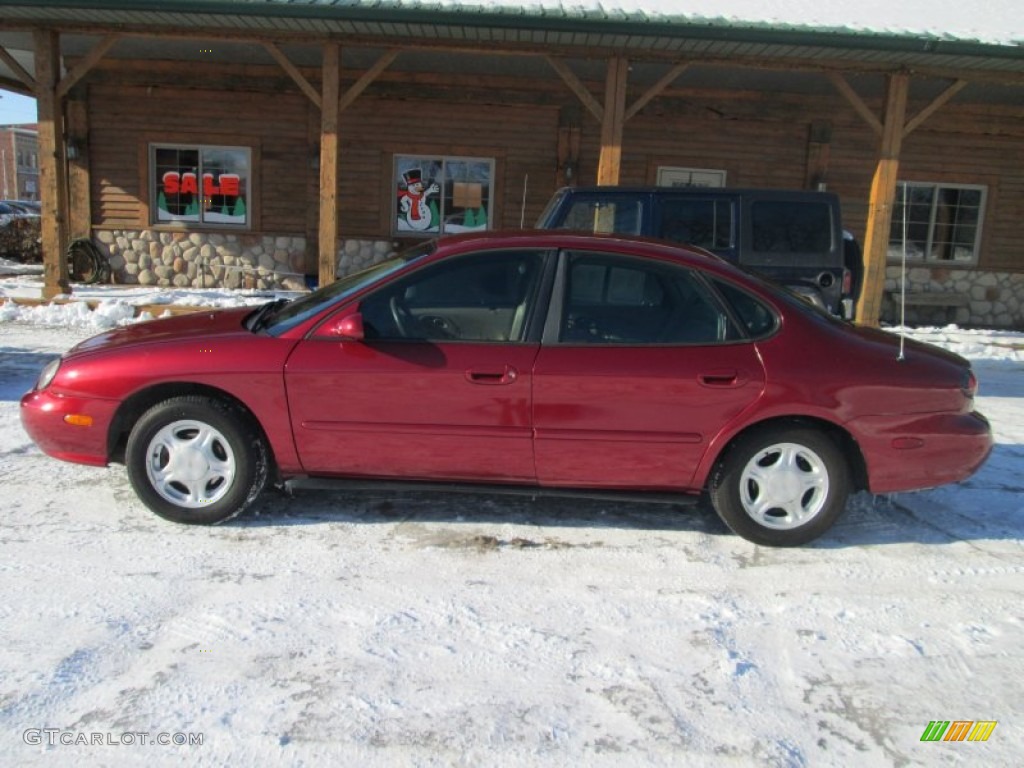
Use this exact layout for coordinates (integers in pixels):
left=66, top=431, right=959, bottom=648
left=708, top=425, right=850, bottom=547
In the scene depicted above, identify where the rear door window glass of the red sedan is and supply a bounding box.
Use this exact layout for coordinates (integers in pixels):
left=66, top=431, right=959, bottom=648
left=558, top=254, right=739, bottom=344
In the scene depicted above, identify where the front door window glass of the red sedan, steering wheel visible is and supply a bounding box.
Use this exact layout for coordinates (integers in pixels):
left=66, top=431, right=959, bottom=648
left=359, top=251, right=544, bottom=342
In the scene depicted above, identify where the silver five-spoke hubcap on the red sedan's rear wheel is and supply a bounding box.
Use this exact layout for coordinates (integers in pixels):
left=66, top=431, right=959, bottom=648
left=739, top=442, right=828, bottom=529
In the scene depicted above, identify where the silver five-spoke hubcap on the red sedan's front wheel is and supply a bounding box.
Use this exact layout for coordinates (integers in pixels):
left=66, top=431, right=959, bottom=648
left=145, top=420, right=237, bottom=509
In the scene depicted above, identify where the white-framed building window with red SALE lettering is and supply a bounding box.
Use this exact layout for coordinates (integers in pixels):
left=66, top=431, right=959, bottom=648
left=150, top=144, right=252, bottom=228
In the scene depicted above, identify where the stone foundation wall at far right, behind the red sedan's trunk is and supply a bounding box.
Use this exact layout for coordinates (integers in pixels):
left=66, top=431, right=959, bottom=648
left=882, top=266, right=1024, bottom=330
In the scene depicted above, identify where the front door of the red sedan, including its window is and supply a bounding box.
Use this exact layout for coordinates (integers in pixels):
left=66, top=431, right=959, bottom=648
left=286, top=250, right=548, bottom=481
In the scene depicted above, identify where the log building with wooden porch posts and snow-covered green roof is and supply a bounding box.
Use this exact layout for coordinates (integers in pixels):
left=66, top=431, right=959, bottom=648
left=0, top=0, right=1024, bottom=329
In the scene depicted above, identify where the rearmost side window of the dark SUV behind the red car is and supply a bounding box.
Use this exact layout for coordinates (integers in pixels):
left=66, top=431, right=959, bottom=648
left=751, top=200, right=833, bottom=253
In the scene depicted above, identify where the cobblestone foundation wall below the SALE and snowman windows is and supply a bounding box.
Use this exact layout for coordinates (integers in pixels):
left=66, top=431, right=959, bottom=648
left=93, top=229, right=395, bottom=291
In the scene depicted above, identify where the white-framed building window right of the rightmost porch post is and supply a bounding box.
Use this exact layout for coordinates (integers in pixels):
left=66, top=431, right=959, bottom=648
left=889, top=181, right=986, bottom=264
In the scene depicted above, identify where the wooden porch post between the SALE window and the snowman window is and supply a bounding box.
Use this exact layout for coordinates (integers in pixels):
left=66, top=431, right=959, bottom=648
left=318, top=43, right=341, bottom=286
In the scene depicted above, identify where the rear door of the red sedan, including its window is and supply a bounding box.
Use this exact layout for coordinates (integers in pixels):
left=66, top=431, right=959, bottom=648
left=534, top=253, right=764, bottom=489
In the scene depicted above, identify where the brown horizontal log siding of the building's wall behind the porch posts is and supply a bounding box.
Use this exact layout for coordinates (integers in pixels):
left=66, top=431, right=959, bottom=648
left=81, top=62, right=1024, bottom=280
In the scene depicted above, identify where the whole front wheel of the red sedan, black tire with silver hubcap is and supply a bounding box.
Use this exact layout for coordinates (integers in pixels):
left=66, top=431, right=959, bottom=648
left=125, top=395, right=269, bottom=525
